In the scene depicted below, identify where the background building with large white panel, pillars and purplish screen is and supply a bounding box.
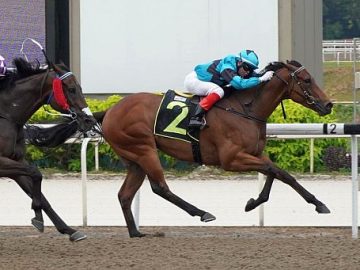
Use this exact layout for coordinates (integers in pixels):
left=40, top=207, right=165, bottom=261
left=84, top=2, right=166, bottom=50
left=0, top=0, right=322, bottom=95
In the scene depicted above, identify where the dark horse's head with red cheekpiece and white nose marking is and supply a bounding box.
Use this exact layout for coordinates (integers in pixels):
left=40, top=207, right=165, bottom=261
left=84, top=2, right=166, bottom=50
left=14, top=58, right=97, bottom=132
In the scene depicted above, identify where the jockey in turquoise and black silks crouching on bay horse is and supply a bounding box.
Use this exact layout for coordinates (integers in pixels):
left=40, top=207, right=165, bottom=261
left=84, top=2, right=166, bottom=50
left=184, top=50, right=274, bottom=128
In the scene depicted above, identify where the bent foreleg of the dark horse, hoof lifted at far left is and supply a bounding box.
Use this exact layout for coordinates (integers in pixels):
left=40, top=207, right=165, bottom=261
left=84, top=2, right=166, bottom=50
left=0, top=157, right=44, bottom=231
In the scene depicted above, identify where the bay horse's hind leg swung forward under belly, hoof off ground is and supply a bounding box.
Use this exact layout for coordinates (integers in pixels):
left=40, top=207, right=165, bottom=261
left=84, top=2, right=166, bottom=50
left=140, top=152, right=215, bottom=225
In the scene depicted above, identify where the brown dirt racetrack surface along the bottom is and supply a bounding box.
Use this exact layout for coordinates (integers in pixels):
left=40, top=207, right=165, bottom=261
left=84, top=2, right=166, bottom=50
left=0, top=227, right=360, bottom=270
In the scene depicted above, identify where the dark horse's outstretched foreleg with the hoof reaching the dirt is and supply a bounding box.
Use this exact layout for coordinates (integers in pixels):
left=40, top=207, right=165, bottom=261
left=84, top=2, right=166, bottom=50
left=14, top=176, right=86, bottom=241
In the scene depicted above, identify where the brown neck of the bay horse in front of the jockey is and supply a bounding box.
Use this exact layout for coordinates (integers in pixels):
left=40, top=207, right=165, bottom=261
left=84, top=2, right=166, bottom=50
left=231, top=75, right=286, bottom=121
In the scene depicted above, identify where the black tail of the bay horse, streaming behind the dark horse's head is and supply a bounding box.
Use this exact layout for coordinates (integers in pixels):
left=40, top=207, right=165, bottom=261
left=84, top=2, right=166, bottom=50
left=25, top=111, right=106, bottom=148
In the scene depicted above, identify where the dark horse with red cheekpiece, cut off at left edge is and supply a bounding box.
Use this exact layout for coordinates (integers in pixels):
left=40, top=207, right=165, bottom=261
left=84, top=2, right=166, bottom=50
left=0, top=58, right=96, bottom=241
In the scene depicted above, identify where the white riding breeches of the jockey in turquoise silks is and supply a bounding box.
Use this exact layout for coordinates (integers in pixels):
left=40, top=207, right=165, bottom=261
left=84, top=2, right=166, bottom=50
left=184, top=71, right=224, bottom=98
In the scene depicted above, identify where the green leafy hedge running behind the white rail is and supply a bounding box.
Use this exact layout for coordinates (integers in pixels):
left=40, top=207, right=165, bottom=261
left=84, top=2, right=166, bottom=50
left=27, top=95, right=352, bottom=172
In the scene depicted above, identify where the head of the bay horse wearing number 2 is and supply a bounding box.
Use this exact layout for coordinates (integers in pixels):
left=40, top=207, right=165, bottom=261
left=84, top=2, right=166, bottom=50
left=265, top=60, right=333, bottom=115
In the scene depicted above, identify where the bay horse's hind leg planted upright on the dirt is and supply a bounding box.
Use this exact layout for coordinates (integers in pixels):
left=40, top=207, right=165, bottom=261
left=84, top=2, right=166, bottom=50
left=118, top=160, right=146, bottom=237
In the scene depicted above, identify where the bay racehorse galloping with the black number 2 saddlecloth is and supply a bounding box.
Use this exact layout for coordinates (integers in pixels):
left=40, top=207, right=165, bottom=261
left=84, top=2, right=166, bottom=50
left=35, top=61, right=333, bottom=237
